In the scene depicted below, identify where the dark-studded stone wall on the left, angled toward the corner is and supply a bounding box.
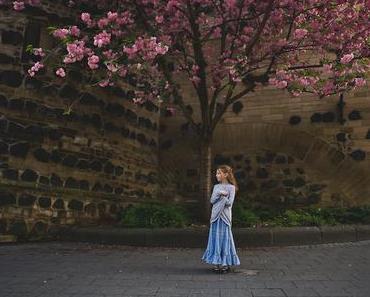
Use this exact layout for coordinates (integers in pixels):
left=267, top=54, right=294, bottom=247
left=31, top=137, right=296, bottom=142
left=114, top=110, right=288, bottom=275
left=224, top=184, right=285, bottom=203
left=0, top=2, right=159, bottom=237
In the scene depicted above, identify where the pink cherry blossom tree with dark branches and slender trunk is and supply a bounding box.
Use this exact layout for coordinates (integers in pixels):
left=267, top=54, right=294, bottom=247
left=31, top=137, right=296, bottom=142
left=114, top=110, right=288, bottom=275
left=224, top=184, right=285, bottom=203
left=0, top=0, right=370, bottom=221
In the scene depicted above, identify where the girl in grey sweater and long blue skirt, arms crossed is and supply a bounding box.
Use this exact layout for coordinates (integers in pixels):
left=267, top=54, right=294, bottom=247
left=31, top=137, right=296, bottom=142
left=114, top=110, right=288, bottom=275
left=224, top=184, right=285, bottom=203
left=202, top=165, right=240, bottom=273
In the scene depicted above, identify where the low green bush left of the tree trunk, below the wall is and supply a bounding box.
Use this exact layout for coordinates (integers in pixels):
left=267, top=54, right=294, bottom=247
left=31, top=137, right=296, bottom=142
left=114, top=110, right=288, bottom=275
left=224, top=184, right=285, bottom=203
left=121, top=203, right=188, bottom=228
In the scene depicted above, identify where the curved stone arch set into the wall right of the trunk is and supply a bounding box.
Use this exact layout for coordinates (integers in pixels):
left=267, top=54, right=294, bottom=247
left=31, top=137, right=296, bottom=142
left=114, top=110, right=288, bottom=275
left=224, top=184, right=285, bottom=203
left=213, top=122, right=370, bottom=205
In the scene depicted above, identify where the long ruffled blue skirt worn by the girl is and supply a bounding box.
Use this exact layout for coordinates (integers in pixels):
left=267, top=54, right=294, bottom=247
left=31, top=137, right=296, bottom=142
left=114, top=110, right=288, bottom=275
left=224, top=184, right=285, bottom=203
left=202, top=218, right=240, bottom=266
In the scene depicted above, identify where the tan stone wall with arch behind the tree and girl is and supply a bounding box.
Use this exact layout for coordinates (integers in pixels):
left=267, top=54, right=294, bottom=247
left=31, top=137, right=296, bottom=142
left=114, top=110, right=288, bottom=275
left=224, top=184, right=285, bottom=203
left=160, top=78, right=370, bottom=207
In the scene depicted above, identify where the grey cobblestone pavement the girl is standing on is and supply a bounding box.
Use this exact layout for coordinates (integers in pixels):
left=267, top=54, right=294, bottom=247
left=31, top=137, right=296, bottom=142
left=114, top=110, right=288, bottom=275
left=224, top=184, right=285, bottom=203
left=0, top=241, right=370, bottom=297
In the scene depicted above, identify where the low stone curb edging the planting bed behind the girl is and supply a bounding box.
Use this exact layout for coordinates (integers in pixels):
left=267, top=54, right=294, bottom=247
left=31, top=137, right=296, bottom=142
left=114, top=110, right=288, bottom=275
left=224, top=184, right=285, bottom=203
left=49, top=225, right=370, bottom=248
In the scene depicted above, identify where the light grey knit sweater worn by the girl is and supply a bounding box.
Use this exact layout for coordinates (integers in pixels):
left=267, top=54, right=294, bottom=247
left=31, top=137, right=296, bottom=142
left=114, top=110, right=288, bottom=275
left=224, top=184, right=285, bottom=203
left=210, top=183, right=235, bottom=226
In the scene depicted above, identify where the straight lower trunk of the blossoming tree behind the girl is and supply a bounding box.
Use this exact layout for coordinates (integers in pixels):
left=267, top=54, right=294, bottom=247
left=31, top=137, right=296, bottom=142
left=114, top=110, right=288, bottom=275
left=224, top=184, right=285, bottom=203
left=199, top=139, right=213, bottom=224
